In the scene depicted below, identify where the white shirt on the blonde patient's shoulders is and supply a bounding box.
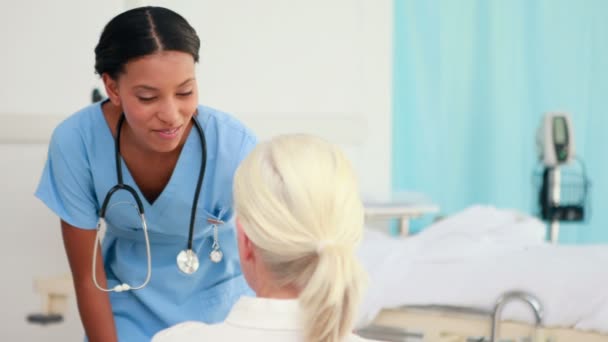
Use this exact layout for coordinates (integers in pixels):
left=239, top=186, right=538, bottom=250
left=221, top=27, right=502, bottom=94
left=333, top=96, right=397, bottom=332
left=152, top=297, right=370, bottom=342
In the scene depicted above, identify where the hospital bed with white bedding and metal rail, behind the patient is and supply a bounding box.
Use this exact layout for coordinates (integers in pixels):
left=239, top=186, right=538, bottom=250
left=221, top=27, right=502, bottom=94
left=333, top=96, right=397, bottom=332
left=359, top=206, right=608, bottom=342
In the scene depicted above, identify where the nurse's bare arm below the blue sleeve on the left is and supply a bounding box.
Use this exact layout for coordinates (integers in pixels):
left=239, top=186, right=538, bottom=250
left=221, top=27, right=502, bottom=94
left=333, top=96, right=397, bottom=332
left=61, top=220, right=117, bottom=342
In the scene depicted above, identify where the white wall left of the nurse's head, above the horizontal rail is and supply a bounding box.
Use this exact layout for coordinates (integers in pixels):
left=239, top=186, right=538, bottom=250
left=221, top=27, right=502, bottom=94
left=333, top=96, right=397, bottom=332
left=0, top=0, right=122, bottom=115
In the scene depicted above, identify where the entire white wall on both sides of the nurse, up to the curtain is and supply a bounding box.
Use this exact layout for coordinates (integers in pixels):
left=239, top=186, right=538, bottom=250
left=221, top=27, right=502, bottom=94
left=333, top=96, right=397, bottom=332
left=0, top=0, right=392, bottom=341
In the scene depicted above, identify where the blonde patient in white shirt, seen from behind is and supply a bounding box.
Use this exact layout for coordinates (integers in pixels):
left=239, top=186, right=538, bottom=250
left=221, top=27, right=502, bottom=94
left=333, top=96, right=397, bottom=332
left=153, top=135, right=378, bottom=342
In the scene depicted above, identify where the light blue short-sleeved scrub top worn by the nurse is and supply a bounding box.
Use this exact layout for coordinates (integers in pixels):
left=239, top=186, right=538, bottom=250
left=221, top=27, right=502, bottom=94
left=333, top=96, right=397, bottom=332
left=36, top=103, right=256, bottom=342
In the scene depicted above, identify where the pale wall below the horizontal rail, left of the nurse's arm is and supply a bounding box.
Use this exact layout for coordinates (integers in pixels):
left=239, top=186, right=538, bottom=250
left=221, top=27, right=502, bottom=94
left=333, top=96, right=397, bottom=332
left=0, top=144, right=83, bottom=341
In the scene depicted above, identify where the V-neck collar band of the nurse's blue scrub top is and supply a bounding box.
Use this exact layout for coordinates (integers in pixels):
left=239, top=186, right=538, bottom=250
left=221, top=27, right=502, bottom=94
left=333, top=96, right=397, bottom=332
left=98, top=101, right=204, bottom=216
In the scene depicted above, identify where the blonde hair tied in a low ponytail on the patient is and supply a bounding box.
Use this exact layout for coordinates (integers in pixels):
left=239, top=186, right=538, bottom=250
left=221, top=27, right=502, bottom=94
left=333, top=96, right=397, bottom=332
left=234, top=135, right=365, bottom=342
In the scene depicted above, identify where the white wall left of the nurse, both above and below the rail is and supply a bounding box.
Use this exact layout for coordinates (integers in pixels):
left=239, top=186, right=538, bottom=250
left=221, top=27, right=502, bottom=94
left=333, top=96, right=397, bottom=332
left=0, top=0, right=122, bottom=341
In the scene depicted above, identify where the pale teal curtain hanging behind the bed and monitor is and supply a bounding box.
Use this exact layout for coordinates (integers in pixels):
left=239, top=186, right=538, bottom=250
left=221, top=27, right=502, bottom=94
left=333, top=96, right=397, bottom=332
left=392, top=0, right=608, bottom=243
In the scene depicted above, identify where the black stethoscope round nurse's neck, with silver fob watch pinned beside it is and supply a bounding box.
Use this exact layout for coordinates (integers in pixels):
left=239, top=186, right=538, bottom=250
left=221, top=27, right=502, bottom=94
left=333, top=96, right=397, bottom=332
left=93, top=114, right=224, bottom=292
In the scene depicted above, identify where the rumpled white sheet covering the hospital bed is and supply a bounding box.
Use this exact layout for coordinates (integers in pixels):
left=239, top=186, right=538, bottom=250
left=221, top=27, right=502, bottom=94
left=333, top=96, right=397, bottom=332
left=359, top=206, right=608, bottom=333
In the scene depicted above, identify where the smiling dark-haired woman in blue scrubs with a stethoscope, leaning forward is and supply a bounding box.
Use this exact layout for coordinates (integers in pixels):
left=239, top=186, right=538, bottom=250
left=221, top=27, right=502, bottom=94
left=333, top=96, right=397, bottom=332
left=36, top=7, right=256, bottom=342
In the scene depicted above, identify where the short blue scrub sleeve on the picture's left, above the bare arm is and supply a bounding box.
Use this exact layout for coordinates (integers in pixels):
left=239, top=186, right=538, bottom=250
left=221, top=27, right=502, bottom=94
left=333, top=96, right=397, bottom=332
left=35, top=119, right=98, bottom=229
